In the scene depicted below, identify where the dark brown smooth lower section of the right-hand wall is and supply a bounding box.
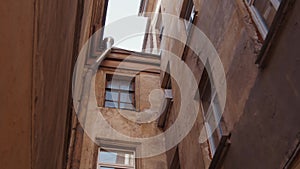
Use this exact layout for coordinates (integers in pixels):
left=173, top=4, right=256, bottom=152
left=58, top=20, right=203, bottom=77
left=224, top=1, right=300, bottom=169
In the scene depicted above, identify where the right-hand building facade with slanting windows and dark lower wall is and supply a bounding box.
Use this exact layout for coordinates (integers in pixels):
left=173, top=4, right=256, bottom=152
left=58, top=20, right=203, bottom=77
left=144, top=0, right=299, bottom=168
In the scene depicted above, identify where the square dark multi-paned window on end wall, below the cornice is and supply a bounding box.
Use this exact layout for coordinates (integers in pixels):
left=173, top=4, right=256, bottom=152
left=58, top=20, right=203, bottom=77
left=104, top=75, right=135, bottom=110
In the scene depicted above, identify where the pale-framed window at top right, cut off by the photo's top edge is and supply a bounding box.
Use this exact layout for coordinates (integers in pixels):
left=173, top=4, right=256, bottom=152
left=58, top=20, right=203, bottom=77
left=246, top=0, right=281, bottom=38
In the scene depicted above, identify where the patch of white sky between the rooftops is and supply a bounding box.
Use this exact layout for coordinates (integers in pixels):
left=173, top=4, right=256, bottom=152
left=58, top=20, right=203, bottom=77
left=104, top=0, right=147, bottom=51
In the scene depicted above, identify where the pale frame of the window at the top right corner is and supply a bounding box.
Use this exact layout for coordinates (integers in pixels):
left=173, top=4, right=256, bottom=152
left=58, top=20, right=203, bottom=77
left=245, top=0, right=281, bottom=39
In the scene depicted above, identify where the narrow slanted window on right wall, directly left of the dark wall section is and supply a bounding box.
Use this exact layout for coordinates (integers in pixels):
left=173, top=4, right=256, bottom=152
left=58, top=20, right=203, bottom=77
left=199, top=64, right=223, bottom=158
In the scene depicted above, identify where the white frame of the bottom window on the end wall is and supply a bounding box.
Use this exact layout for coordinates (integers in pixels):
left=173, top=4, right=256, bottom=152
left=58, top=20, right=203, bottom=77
left=97, top=146, right=136, bottom=169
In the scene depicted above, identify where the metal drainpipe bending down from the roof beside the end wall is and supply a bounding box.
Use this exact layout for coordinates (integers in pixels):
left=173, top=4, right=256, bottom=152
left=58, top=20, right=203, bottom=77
left=66, top=37, right=114, bottom=169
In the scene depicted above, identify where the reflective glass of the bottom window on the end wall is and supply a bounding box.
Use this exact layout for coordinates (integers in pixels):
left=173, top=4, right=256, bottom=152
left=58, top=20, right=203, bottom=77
left=98, top=149, right=134, bottom=166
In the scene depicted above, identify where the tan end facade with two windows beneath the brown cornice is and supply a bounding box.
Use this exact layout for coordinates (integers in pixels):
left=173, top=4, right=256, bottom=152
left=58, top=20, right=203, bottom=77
left=70, top=48, right=167, bottom=169
